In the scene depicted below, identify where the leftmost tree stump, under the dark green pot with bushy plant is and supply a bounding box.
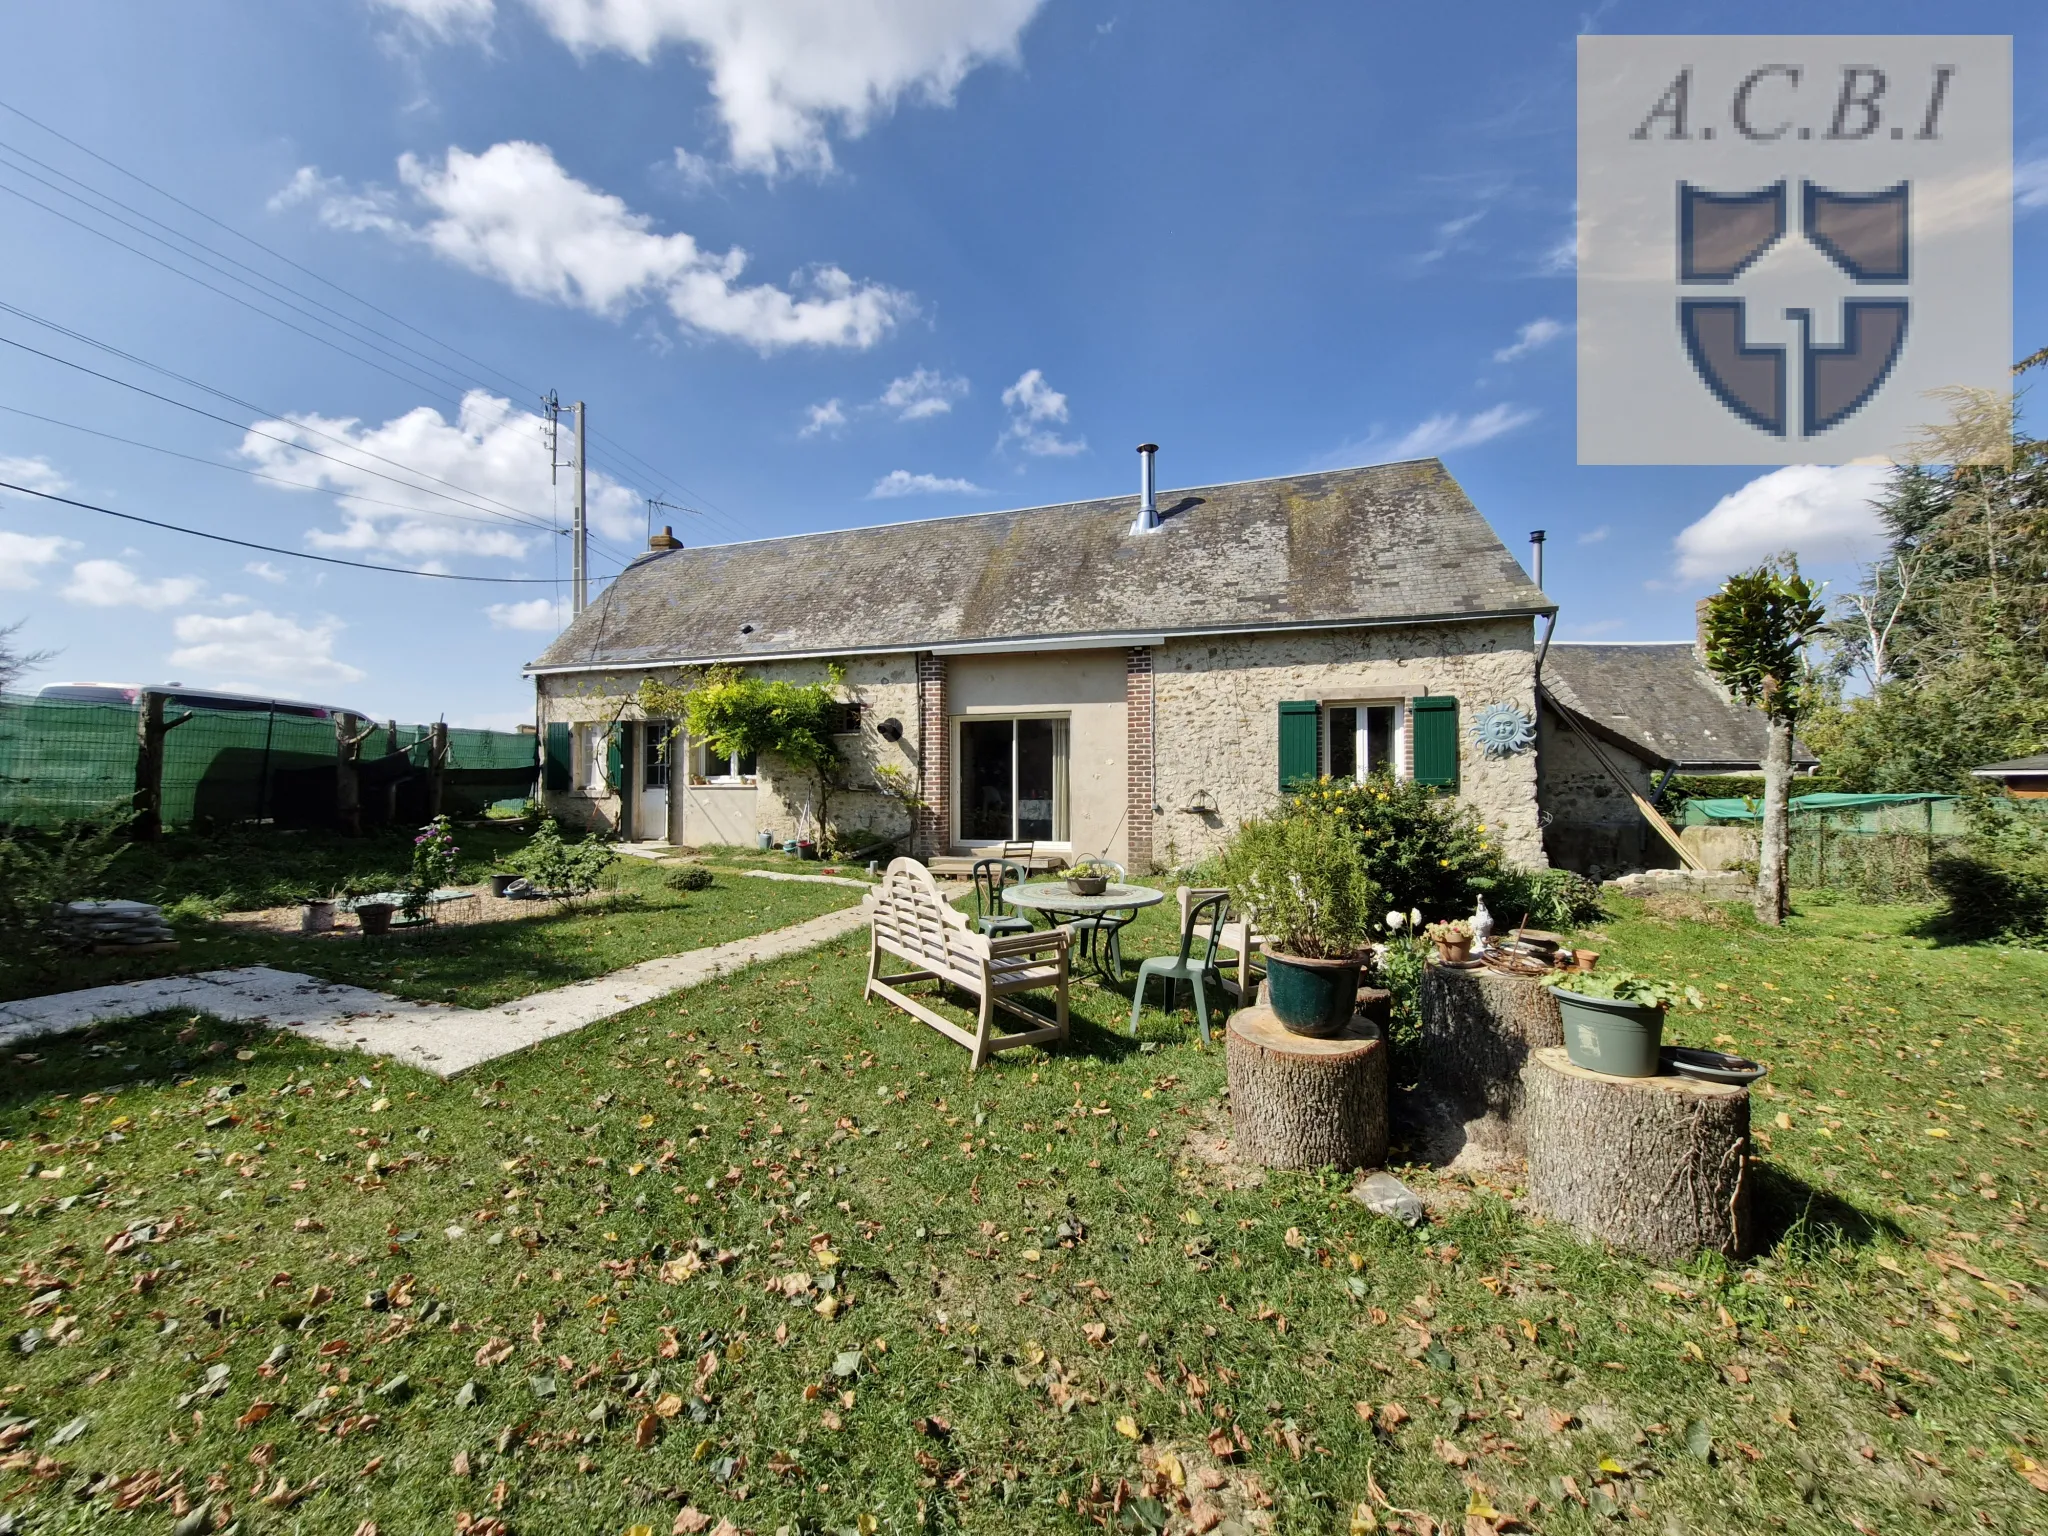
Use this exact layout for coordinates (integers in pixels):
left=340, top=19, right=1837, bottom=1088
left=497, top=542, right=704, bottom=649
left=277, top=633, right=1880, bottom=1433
left=1225, top=1008, right=1386, bottom=1169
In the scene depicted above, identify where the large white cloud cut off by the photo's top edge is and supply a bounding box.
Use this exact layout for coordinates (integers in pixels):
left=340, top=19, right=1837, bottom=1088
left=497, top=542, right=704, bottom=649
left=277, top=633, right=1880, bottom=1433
left=377, top=0, right=1042, bottom=176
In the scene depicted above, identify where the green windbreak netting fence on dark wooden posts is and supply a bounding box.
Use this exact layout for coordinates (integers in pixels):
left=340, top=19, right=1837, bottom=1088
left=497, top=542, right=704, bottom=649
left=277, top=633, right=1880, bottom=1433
left=0, top=694, right=537, bottom=827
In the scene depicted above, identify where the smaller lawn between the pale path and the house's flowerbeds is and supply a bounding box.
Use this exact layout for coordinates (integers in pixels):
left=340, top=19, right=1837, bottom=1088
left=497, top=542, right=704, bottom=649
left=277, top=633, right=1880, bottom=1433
left=0, top=827, right=860, bottom=1008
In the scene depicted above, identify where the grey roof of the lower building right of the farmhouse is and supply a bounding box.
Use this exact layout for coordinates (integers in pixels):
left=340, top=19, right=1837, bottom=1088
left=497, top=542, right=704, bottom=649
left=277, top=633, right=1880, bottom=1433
left=1542, top=641, right=1817, bottom=772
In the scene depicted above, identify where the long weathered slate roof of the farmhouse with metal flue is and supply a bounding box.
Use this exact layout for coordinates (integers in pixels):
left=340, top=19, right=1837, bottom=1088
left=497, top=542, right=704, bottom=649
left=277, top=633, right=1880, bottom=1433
left=530, top=459, right=1552, bottom=672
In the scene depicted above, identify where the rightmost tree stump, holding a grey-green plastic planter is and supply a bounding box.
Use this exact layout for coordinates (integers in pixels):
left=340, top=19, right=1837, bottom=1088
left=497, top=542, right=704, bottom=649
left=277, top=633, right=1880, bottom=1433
left=1522, top=1047, right=1749, bottom=1264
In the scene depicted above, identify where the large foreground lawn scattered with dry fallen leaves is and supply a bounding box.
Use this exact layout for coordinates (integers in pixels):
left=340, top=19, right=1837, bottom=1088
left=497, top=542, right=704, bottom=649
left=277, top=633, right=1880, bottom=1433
left=0, top=897, right=2048, bottom=1536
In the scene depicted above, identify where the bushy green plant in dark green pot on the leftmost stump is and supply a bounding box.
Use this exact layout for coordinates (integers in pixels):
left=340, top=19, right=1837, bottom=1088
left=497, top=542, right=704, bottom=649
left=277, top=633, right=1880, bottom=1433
left=1221, top=813, right=1380, bottom=1036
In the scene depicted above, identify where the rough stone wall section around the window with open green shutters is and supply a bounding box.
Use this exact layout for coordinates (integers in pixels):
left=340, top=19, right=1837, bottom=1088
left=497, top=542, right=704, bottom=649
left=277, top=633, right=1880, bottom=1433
left=1153, top=618, right=1544, bottom=866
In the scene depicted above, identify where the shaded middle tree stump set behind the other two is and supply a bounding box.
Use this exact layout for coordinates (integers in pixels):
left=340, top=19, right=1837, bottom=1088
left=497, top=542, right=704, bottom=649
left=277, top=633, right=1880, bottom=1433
left=1417, top=961, right=1565, bottom=1157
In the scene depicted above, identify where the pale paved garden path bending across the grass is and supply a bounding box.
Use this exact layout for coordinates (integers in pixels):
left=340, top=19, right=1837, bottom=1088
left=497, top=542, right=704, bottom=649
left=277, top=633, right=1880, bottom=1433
left=0, top=905, right=868, bottom=1077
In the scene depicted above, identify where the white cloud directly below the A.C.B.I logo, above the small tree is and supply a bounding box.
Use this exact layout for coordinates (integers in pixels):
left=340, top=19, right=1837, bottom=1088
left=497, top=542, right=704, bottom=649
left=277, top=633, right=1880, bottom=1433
left=1675, top=465, right=1890, bottom=582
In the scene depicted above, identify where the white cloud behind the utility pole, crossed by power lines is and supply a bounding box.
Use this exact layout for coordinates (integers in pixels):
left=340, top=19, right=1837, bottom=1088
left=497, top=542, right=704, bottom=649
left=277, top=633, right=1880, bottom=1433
left=240, top=389, right=643, bottom=561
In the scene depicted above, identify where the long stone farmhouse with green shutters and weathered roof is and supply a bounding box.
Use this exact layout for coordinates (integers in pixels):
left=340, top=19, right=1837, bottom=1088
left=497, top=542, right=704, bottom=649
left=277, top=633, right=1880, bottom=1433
left=528, top=451, right=1777, bottom=872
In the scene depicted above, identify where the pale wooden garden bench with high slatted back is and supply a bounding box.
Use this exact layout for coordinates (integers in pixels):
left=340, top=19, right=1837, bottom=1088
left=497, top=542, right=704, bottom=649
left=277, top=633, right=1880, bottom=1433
left=862, top=858, right=1069, bottom=1071
